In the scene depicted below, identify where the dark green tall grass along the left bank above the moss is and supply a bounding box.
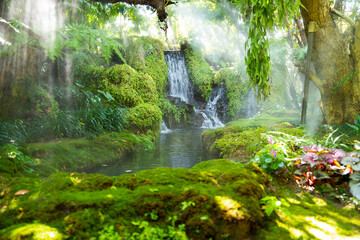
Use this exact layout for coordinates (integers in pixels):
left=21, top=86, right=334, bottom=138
left=0, top=91, right=126, bottom=146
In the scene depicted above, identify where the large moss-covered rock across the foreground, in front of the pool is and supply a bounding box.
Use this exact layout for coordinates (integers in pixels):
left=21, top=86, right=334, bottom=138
left=0, top=160, right=269, bottom=239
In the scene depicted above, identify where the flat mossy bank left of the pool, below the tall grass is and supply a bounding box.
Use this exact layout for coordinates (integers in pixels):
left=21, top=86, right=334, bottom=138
left=27, top=132, right=151, bottom=176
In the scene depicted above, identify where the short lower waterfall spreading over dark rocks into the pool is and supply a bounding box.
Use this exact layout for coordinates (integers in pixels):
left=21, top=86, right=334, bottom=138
left=195, top=88, right=225, bottom=128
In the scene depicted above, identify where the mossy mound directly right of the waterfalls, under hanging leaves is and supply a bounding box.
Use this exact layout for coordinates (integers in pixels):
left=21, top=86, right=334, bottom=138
left=214, top=68, right=248, bottom=118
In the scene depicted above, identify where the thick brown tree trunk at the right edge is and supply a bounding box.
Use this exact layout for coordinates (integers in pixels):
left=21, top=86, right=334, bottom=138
left=301, top=0, right=360, bottom=124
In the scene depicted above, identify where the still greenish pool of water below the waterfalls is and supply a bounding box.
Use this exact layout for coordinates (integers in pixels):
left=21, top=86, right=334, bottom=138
left=84, top=129, right=208, bottom=176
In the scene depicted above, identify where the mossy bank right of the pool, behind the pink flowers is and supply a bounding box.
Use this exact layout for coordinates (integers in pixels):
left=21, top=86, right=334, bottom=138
left=201, top=111, right=304, bottom=161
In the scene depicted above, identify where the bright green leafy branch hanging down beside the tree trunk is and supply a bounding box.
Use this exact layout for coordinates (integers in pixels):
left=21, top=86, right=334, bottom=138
left=233, top=0, right=300, bottom=98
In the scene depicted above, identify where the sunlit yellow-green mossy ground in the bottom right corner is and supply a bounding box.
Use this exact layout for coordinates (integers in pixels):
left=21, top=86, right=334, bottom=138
left=257, top=183, right=360, bottom=240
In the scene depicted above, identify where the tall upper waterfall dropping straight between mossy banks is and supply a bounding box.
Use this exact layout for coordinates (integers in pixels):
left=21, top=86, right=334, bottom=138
left=164, top=51, right=192, bottom=103
